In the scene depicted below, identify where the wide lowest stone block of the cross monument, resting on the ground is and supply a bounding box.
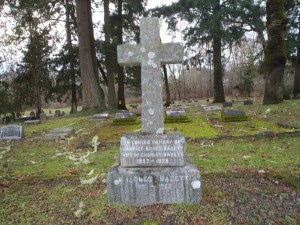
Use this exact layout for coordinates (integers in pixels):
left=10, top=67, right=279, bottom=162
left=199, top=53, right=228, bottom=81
left=107, top=163, right=201, bottom=206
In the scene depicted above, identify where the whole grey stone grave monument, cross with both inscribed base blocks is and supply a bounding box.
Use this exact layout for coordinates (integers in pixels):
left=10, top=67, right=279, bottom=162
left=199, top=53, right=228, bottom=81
left=107, top=17, right=201, bottom=205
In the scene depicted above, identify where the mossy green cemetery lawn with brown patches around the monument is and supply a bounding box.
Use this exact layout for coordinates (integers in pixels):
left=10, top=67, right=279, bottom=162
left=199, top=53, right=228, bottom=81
left=0, top=100, right=300, bottom=225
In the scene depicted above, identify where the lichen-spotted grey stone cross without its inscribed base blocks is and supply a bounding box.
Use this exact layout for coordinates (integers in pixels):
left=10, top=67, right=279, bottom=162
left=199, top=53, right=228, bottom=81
left=117, top=17, right=183, bottom=134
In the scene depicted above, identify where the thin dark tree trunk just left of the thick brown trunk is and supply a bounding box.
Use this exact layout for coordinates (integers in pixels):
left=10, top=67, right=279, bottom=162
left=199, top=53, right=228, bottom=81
left=66, top=0, right=77, bottom=113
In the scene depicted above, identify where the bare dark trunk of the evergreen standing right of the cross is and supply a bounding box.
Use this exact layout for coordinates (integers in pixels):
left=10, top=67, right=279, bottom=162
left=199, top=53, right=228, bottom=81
left=213, top=0, right=225, bottom=103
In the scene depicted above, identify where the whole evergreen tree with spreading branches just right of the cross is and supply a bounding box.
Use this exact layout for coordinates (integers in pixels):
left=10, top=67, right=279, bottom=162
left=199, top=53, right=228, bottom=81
left=154, top=0, right=251, bottom=102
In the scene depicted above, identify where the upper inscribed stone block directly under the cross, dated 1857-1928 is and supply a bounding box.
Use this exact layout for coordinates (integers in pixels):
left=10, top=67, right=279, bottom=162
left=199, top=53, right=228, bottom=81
left=120, top=133, right=185, bottom=167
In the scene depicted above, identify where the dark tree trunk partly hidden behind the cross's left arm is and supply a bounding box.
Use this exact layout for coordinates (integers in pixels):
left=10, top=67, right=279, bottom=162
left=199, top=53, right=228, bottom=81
left=116, top=0, right=126, bottom=109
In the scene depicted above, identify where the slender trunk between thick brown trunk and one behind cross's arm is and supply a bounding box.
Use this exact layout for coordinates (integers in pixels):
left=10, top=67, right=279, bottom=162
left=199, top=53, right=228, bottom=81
left=104, top=0, right=117, bottom=109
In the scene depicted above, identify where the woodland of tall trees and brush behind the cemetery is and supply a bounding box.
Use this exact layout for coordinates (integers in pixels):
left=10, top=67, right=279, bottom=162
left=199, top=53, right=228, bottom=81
left=0, top=0, right=300, bottom=116
